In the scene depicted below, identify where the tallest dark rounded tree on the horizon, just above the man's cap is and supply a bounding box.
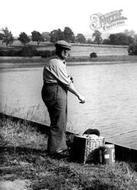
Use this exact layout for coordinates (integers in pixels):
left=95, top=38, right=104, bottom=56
left=64, top=27, right=75, bottom=42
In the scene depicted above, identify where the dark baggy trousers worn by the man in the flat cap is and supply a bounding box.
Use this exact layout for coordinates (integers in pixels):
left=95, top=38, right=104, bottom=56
left=42, top=84, right=67, bottom=153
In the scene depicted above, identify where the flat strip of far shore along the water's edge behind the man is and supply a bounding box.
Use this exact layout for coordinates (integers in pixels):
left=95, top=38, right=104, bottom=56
left=0, top=55, right=137, bottom=69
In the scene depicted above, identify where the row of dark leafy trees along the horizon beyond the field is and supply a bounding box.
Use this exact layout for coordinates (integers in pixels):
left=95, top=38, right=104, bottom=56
left=0, top=27, right=137, bottom=46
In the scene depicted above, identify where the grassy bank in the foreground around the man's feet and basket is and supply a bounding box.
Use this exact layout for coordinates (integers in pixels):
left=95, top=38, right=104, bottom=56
left=0, top=117, right=137, bottom=190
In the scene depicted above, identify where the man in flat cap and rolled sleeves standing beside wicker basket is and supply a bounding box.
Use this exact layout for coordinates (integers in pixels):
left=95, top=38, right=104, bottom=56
left=42, top=40, right=85, bottom=155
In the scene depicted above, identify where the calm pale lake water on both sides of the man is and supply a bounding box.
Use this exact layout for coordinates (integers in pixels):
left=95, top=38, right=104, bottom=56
left=0, top=64, right=137, bottom=146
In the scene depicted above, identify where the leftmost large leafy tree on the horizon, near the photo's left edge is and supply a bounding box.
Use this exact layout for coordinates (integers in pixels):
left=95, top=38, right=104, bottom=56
left=2, top=27, right=14, bottom=46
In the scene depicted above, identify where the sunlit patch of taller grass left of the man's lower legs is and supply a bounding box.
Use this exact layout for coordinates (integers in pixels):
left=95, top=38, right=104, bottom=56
left=0, top=118, right=47, bottom=149
